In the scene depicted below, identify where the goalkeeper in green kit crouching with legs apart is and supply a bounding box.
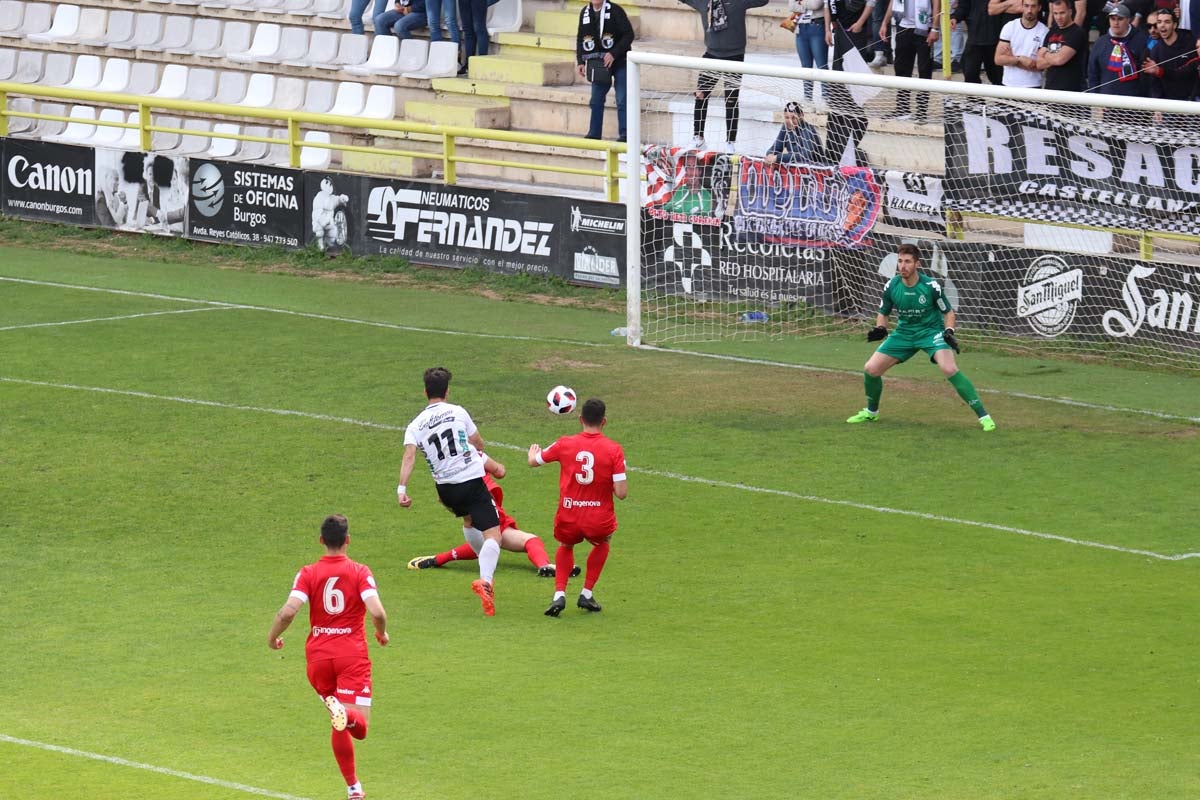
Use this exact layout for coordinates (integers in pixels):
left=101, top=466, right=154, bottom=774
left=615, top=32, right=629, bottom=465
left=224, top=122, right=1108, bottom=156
left=846, top=243, right=996, bottom=431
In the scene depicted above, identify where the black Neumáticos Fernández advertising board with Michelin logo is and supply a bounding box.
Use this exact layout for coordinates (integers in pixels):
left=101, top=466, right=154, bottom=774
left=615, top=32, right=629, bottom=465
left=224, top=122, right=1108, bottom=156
left=324, top=173, right=625, bottom=285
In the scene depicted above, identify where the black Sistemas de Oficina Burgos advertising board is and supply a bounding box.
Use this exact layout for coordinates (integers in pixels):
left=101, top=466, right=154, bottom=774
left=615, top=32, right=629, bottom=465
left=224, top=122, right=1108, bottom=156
left=187, top=158, right=305, bottom=249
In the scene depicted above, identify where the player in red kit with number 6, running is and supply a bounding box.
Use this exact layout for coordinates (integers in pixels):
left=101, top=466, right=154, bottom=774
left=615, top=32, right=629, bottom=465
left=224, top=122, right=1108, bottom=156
left=266, top=515, right=388, bottom=800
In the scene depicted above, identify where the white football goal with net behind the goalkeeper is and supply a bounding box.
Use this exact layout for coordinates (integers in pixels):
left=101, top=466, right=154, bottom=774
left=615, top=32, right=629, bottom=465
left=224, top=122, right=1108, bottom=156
left=625, top=50, right=1200, bottom=371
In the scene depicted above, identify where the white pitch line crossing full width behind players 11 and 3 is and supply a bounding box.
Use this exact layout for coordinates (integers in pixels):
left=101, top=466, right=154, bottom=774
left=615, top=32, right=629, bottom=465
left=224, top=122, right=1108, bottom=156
left=0, top=377, right=1200, bottom=561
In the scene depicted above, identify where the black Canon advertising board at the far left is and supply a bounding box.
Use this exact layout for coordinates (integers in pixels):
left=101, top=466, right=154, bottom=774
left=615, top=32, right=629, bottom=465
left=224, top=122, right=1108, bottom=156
left=2, top=139, right=96, bottom=225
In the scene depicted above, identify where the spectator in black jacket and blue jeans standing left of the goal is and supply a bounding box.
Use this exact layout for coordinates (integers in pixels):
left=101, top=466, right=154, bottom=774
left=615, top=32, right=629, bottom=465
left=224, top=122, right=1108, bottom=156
left=575, top=0, right=634, bottom=142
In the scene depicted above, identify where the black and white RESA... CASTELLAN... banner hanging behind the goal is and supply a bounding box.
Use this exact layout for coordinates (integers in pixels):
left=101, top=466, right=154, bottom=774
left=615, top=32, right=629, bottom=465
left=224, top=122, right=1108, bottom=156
left=946, top=97, right=1200, bottom=235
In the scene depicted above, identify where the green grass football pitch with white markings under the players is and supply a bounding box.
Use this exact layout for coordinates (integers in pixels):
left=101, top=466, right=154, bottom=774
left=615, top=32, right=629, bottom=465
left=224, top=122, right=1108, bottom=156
left=0, top=246, right=1200, bottom=800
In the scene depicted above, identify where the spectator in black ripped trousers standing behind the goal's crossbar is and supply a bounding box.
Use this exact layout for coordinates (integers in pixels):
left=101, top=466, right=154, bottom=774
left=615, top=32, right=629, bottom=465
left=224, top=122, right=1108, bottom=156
left=680, top=0, right=768, bottom=152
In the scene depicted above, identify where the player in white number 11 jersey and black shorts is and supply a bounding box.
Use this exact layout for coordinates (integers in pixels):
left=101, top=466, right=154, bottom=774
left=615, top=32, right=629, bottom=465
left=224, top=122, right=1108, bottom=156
left=396, top=367, right=500, bottom=616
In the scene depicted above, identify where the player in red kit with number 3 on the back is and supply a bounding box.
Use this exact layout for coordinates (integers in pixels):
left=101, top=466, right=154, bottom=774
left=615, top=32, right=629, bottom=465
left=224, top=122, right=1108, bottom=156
left=529, top=398, right=629, bottom=616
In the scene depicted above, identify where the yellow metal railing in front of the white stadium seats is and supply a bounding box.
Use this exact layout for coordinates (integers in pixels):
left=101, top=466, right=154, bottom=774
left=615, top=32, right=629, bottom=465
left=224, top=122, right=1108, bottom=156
left=0, top=82, right=625, bottom=203
